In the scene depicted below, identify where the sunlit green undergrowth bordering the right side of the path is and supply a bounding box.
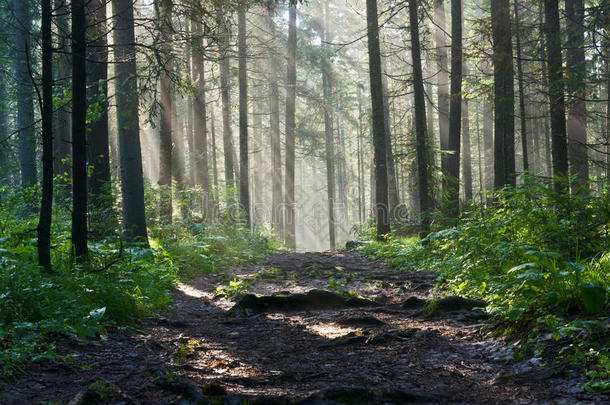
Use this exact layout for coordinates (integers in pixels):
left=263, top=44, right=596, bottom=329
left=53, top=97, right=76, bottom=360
left=361, top=181, right=610, bottom=390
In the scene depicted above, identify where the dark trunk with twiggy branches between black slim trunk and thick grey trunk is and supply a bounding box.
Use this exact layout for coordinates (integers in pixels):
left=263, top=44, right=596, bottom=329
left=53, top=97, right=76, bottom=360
left=87, top=0, right=112, bottom=215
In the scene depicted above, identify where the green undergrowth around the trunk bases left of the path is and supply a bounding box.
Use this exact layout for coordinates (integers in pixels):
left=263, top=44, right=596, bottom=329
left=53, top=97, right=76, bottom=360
left=0, top=188, right=275, bottom=376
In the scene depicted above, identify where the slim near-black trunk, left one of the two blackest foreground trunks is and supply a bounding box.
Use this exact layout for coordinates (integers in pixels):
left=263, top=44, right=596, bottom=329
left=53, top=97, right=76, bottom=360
left=37, top=0, right=53, bottom=272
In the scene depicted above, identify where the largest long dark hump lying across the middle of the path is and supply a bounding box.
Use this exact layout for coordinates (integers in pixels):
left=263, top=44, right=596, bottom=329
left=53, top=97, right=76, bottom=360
left=230, top=290, right=378, bottom=314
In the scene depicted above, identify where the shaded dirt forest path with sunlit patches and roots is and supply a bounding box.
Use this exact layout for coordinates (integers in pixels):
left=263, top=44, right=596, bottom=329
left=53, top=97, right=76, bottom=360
left=0, top=252, right=607, bottom=405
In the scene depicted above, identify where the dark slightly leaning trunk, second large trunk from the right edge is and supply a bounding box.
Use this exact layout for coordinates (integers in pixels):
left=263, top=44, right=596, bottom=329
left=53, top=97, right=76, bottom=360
left=544, top=0, right=568, bottom=193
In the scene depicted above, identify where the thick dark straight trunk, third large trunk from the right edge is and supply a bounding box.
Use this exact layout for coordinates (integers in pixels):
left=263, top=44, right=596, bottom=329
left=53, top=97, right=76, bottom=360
left=491, top=0, right=516, bottom=188
